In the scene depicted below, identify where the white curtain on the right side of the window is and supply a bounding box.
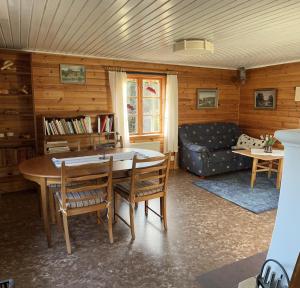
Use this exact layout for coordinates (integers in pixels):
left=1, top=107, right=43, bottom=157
left=164, top=75, right=178, bottom=153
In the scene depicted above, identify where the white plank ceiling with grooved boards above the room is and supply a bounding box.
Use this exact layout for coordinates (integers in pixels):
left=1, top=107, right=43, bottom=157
left=0, top=0, right=300, bottom=68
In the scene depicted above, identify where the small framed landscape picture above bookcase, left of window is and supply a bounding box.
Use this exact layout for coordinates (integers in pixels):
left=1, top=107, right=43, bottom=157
left=60, top=64, right=85, bottom=84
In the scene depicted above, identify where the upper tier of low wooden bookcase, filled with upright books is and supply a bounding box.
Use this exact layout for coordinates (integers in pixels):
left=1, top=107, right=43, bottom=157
left=37, top=111, right=115, bottom=154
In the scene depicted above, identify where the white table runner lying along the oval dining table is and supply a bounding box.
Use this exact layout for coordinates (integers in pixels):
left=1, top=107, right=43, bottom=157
left=52, top=151, right=148, bottom=168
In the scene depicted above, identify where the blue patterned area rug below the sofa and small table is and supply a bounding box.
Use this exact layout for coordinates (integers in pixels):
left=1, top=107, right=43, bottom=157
left=194, top=171, right=279, bottom=214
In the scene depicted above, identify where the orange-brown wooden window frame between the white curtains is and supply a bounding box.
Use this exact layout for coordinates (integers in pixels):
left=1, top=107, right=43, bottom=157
left=127, top=74, right=166, bottom=138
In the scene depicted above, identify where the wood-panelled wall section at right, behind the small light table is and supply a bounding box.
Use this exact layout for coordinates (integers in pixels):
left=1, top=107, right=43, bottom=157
left=239, top=63, right=300, bottom=137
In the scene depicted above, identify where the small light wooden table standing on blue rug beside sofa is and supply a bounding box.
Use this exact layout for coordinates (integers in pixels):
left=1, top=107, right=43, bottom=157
left=232, top=150, right=284, bottom=189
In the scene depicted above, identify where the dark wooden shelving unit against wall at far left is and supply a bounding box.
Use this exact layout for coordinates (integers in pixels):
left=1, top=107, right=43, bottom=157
left=0, top=50, right=36, bottom=193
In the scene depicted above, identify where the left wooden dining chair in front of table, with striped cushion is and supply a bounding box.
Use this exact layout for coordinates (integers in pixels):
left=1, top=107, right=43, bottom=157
left=55, top=157, right=113, bottom=254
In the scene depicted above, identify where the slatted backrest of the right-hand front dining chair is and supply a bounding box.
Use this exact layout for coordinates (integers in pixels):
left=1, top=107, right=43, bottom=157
left=130, top=153, right=171, bottom=199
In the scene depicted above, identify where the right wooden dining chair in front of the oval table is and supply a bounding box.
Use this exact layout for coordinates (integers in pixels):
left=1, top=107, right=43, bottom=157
left=114, top=154, right=170, bottom=239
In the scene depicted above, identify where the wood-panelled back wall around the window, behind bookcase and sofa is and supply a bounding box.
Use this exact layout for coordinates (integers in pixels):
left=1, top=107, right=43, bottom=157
left=32, top=53, right=239, bottom=123
